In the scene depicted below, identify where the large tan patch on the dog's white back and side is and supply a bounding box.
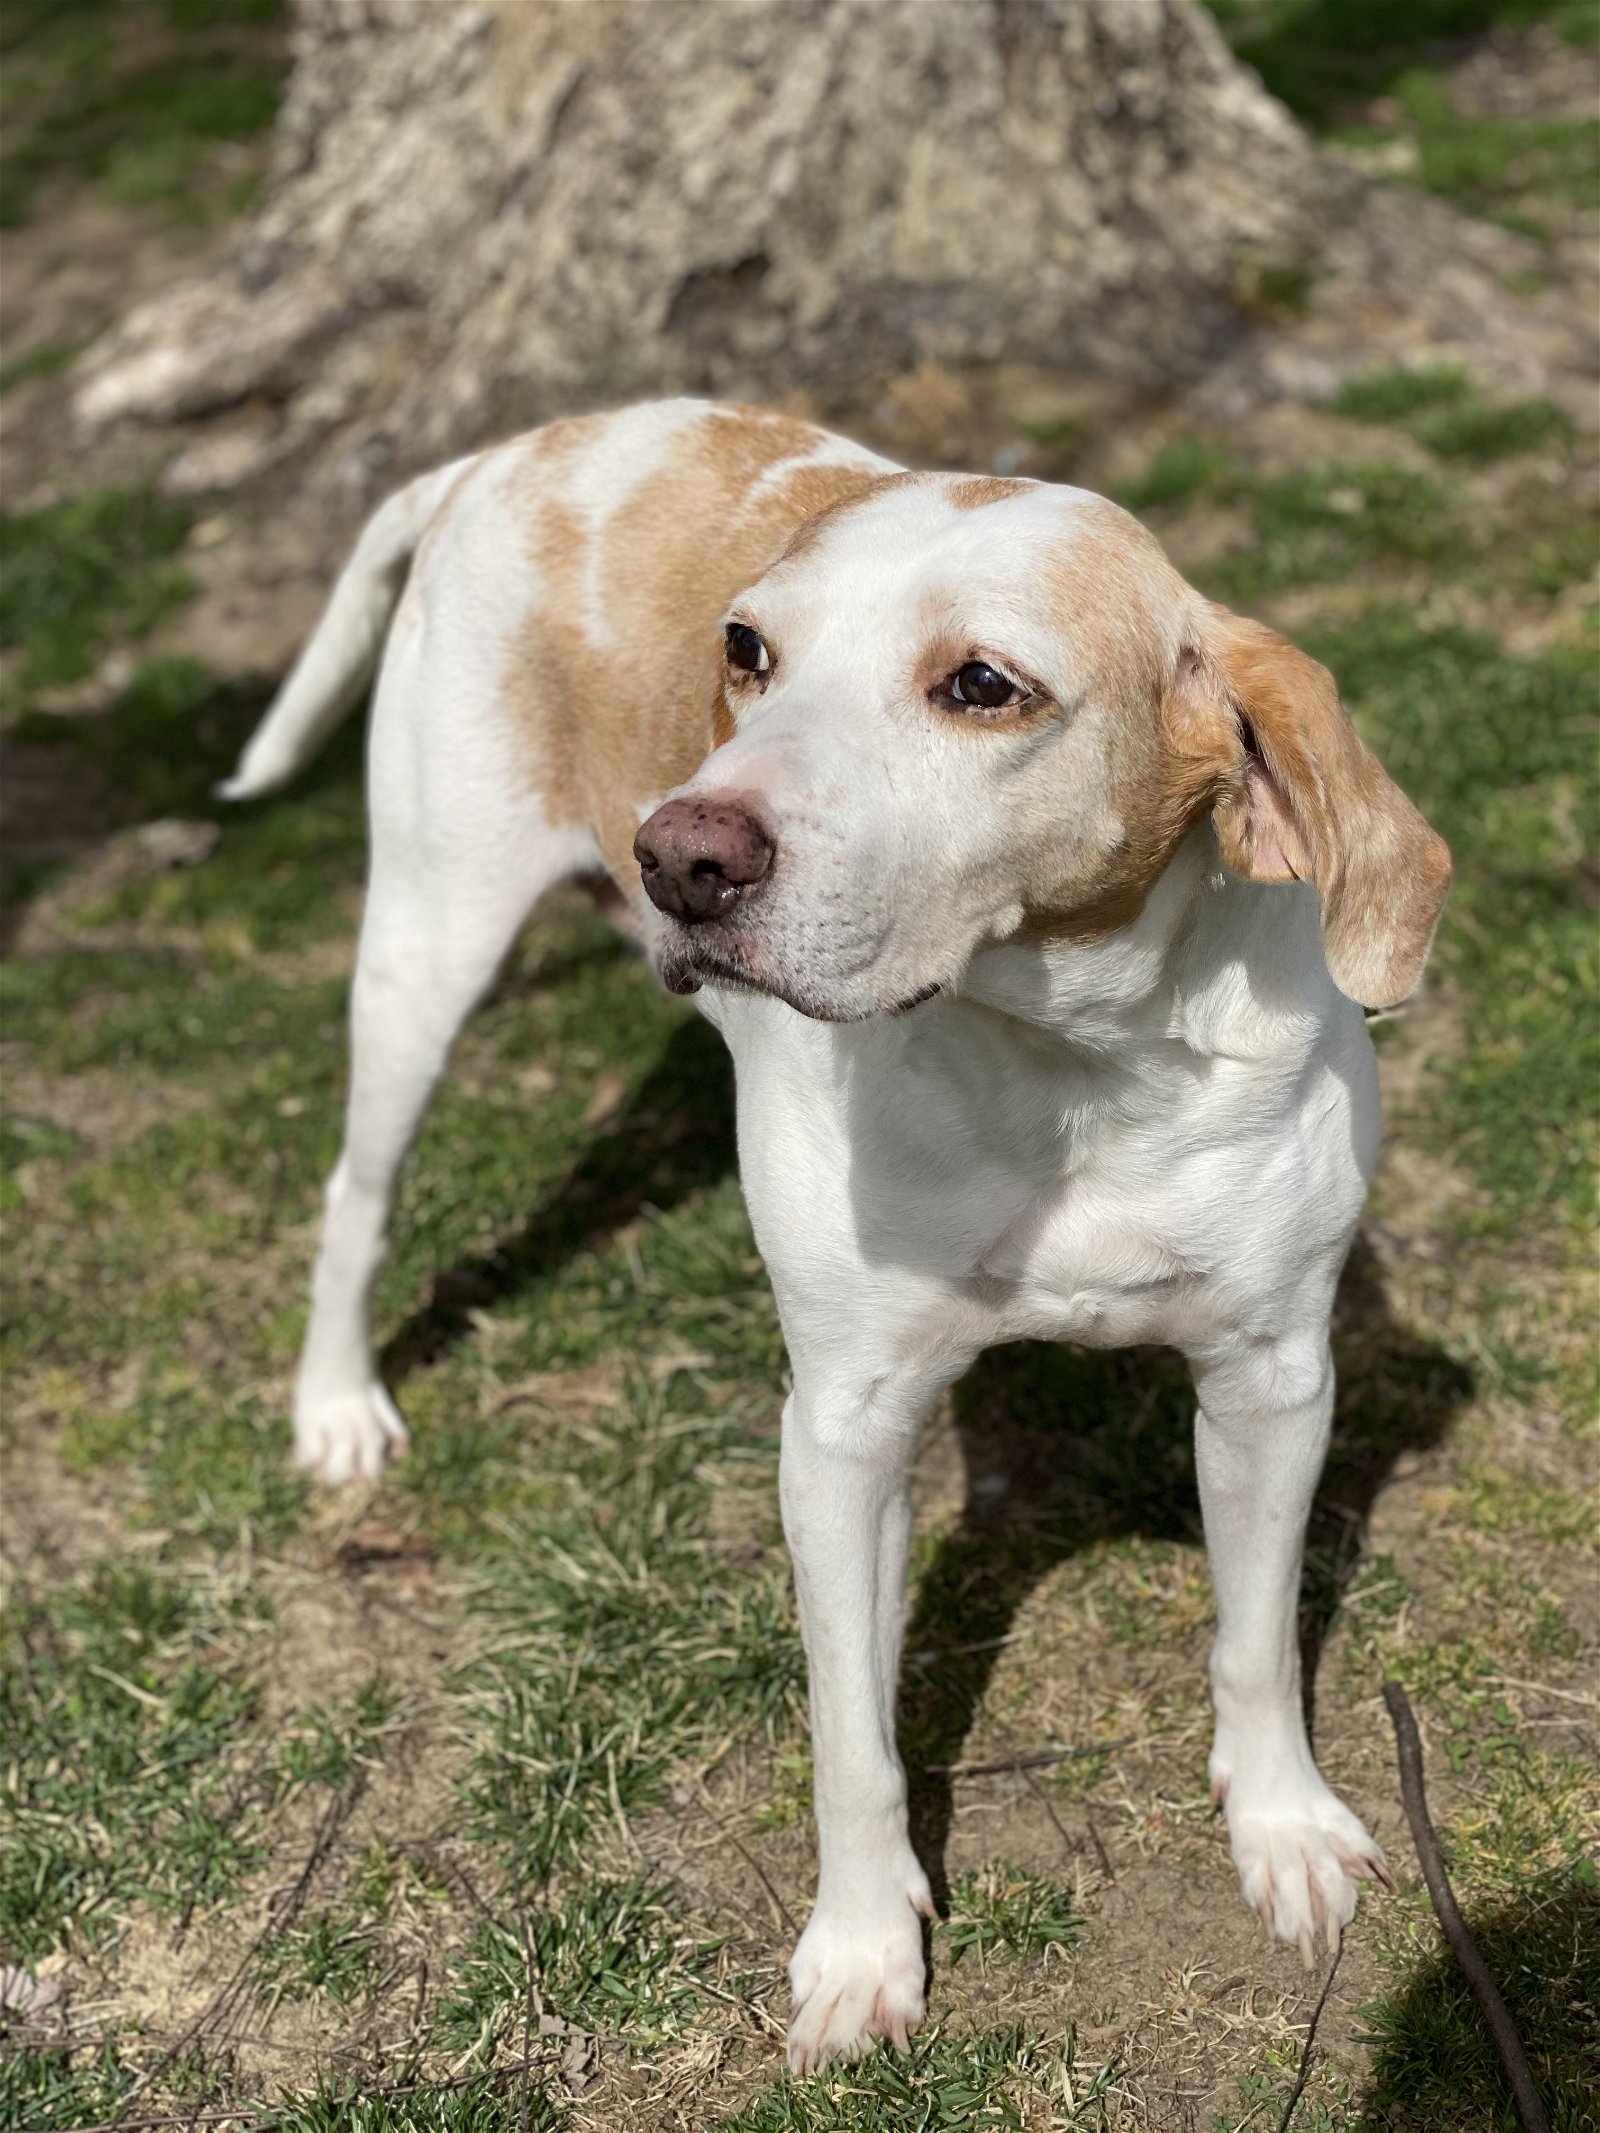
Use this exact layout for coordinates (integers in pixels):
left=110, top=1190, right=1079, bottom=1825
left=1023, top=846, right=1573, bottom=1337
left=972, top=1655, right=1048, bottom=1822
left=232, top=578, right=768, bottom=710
left=501, top=407, right=894, bottom=898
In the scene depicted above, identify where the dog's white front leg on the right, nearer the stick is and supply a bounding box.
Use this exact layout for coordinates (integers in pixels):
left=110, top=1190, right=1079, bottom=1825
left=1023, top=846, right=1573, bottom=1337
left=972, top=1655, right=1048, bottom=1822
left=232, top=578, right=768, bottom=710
left=1190, top=1337, right=1387, bottom=1962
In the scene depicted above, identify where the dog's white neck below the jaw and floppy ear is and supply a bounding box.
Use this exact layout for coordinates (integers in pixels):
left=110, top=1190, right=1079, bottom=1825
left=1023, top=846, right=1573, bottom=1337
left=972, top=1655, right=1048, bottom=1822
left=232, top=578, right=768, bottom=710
left=958, top=823, right=1359, bottom=1062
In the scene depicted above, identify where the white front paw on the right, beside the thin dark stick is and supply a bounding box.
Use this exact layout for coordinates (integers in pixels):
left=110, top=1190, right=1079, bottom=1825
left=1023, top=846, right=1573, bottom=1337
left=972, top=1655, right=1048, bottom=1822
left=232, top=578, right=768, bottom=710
left=1212, top=1764, right=1393, bottom=1969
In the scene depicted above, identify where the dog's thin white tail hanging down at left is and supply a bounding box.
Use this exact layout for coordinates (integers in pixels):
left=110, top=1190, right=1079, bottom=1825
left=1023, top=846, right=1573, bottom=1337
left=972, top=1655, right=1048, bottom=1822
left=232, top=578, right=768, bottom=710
left=218, top=459, right=467, bottom=800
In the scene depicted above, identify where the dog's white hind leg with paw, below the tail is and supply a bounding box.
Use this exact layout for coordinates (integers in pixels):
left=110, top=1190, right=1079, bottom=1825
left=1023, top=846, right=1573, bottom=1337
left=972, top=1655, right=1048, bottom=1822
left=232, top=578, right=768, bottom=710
left=294, top=646, right=597, bottom=1482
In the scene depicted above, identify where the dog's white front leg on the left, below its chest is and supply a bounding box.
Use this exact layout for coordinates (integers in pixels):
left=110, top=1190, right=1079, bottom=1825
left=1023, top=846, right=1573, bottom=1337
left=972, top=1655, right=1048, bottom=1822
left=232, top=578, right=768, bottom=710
left=781, top=1376, right=932, bottom=2073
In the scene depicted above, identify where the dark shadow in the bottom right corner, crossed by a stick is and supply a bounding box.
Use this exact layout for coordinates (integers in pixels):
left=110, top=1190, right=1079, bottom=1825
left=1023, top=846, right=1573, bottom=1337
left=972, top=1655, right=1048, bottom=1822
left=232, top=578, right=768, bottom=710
left=1361, top=1866, right=1600, bottom=2133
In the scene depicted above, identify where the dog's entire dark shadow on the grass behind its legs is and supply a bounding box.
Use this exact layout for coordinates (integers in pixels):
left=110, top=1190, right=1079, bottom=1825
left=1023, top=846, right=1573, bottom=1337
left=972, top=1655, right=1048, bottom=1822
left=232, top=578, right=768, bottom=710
left=382, top=1028, right=1472, bottom=1903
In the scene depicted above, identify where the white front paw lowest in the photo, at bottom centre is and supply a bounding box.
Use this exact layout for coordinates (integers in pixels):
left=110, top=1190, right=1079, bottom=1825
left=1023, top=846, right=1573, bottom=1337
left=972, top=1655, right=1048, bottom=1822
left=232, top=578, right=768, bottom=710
left=789, top=1864, right=934, bottom=2073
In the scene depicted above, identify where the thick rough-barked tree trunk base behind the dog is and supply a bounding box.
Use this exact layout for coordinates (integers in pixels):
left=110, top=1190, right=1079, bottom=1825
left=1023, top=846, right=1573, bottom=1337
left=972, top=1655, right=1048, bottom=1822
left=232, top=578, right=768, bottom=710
left=77, top=0, right=1553, bottom=520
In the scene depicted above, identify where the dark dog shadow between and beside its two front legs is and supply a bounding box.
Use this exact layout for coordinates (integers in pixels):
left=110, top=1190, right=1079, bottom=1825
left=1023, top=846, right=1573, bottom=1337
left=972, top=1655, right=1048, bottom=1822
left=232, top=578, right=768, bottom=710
left=900, top=1244, right=1472, bottom=1901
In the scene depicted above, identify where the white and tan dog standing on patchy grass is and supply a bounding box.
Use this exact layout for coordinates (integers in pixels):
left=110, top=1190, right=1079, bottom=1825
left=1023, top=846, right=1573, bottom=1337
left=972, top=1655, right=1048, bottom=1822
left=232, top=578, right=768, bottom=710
left=224, top=401, right=1449, bottom=2069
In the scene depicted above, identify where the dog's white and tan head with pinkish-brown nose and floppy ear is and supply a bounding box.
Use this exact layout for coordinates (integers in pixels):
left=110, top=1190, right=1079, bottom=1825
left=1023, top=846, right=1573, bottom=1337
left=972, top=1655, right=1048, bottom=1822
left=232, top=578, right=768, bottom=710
left=636, top=476, right=1449, bottom=1020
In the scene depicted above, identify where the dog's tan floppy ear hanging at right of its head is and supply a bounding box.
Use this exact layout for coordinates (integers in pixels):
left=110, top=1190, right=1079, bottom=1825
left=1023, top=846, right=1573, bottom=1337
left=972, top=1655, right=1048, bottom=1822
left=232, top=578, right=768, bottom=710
left=1180, top=606, right=1451, bottom=1007
